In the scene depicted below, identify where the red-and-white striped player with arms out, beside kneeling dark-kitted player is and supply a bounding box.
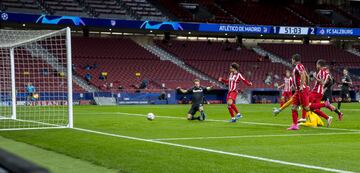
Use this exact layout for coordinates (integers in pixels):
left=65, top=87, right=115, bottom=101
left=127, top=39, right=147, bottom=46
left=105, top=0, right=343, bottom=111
left=219, top=63, right=252, bottom=122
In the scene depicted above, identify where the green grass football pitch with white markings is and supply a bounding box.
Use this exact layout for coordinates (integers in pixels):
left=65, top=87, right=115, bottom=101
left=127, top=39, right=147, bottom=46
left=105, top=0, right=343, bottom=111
left=0, top=103, right=360, bottom=173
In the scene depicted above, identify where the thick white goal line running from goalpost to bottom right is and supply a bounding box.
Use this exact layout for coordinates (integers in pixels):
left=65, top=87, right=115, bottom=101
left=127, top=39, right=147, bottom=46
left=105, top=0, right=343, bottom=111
left=73, top=127, right=353, bottom=173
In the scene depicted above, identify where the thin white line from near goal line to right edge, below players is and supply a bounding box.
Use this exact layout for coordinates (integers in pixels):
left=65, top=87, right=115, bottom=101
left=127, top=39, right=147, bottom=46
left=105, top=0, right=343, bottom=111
left=151, top=132, right=360, bottom=141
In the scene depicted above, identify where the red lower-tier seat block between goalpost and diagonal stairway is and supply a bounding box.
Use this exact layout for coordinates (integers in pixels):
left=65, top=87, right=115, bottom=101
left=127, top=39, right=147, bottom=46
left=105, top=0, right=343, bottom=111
left=73, top=37, right=208, bottom=90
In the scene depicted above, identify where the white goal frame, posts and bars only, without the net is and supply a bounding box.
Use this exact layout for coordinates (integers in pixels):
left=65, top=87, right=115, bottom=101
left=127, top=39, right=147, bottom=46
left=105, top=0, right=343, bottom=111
left=0, top=27, right=74, bottom=131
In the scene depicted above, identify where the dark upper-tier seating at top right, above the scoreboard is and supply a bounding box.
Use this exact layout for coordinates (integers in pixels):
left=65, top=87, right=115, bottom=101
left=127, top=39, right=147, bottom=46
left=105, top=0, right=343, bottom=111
left=219, top=0, right=360, bottom=27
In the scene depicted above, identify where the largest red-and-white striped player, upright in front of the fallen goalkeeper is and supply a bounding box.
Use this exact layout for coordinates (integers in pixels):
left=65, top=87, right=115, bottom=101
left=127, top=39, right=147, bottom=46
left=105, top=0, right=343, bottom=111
left=288, top=54, right=310, bottom=130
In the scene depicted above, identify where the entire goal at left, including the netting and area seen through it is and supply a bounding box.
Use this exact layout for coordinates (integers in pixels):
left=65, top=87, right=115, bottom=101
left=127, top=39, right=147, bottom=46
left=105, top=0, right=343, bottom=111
left=0, top=28, right=73, bottom=130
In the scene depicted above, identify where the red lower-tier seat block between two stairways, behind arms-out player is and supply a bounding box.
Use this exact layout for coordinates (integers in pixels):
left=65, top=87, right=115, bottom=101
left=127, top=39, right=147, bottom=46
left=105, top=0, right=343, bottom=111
left=155, top=41, right=287, bottom=88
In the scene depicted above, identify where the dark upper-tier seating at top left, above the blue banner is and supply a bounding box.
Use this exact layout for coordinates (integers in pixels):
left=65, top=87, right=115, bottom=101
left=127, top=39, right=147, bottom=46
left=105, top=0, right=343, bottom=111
left=1, top=0, right=167, bottom=21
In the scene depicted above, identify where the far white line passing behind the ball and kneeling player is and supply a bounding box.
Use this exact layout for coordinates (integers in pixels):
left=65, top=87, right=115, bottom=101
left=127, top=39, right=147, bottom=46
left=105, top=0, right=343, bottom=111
left=107, top=112, right=360, bottom=132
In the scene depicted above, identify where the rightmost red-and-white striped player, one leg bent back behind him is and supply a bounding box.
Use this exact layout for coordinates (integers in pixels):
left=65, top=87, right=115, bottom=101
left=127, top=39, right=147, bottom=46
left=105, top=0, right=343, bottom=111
left=309, top=59, right=343, bottom=127
